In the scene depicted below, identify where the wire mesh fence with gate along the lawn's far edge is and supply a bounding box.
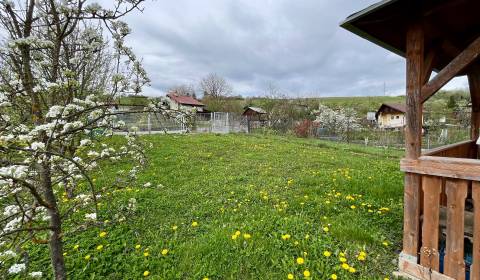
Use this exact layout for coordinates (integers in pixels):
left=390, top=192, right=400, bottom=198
left=115, top=112, right=470, bottom=149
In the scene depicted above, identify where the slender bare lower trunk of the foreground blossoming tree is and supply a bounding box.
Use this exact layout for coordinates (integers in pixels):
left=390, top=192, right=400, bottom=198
left=40, top=164, right=66, bottom=280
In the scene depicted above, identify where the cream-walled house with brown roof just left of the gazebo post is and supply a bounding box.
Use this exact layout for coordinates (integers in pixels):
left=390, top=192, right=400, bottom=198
left=375, top=103, right=406, bottom=129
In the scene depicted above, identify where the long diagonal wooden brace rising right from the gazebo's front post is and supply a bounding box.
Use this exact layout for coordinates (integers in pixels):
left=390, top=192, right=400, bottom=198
left=422, top=37, right=480, bottom=103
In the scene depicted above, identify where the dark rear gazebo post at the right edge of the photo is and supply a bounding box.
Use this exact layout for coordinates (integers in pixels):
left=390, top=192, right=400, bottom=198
left=468, top=65, right=480, bottom=140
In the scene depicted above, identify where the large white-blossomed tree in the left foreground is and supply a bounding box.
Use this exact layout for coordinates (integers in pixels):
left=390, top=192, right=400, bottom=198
left=0, top=0, right=162, bottom=279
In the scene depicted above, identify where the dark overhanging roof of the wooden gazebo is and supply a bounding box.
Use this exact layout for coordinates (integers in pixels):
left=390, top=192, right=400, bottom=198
left=341, top=0, right=480, bottom=75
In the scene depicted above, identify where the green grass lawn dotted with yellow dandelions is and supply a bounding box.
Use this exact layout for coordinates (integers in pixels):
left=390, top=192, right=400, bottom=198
left=23, top=135, right=403, bottom=279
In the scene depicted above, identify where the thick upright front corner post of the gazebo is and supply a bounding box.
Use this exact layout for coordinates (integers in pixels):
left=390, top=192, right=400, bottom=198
left=403, top=22, right=425, bottom=262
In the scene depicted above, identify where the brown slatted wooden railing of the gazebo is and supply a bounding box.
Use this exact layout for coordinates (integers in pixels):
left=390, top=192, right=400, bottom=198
left=400, top=153, right=480, bottom=280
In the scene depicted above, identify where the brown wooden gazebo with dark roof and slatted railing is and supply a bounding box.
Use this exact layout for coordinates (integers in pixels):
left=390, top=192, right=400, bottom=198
left=342, top=0, right=480, bottom=280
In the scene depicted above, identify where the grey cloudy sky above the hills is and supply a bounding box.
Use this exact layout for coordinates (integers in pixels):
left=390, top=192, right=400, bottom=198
left=122, top=0, right=467, bottom=97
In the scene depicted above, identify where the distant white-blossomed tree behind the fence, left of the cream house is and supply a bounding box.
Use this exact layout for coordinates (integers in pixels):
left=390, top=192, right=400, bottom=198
left=312, top=104, right=360, bottom=141
